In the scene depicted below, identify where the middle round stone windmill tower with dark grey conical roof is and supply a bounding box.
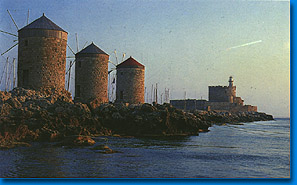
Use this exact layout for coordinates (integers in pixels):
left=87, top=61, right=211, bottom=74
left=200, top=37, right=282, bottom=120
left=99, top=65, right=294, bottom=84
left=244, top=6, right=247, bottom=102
left=75, top=43, right=109, bottom=103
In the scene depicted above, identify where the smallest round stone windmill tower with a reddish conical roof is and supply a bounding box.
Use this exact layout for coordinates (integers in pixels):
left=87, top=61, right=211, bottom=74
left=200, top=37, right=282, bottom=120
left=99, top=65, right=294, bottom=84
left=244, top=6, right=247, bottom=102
left=116, top=57, right=144, bottom=104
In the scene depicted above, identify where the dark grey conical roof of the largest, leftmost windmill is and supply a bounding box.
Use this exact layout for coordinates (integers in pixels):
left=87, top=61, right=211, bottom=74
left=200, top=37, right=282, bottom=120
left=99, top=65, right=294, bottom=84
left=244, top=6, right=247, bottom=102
left=19, top=14, right=66, bottom=32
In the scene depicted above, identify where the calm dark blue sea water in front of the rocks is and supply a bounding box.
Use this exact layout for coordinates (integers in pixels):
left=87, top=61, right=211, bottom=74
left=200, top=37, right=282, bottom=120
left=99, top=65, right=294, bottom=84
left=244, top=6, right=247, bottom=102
left=0, top=119, right=290, bottom=178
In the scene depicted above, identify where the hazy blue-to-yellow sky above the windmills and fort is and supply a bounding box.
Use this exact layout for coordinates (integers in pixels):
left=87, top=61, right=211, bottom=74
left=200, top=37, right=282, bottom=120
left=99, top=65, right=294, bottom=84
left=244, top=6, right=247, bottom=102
left=0, top=0, right=290, bottom=117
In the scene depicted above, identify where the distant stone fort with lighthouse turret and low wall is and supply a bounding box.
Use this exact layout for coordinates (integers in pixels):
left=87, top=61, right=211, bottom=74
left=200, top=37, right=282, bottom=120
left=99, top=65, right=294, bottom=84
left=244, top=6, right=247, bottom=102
left=170, top=76, right=257, bottom=112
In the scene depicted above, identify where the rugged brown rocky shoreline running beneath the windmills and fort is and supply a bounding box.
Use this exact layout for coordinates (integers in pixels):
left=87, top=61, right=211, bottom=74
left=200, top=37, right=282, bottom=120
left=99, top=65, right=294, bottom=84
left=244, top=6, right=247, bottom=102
left=0, top=88, right=273, bottom=148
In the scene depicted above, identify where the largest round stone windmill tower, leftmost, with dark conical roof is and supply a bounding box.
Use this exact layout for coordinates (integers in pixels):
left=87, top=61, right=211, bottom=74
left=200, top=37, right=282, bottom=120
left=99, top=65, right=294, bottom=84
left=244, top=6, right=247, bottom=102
left=18, top=14, right=67, bottom=90
